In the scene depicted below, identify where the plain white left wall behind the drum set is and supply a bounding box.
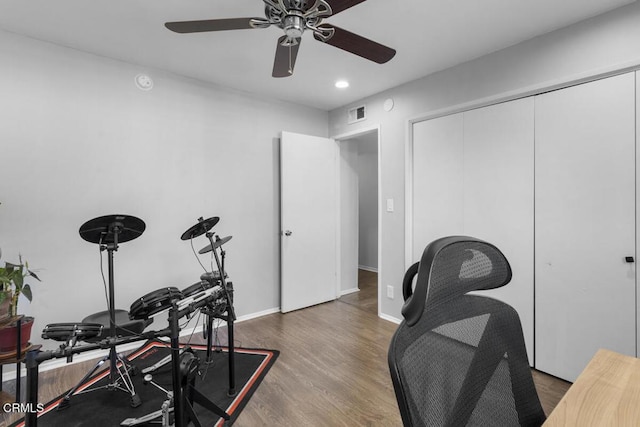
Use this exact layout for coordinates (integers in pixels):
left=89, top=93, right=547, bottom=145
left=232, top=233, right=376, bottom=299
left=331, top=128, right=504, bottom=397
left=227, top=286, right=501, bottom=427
left=0, top=32, right=328, bottom=346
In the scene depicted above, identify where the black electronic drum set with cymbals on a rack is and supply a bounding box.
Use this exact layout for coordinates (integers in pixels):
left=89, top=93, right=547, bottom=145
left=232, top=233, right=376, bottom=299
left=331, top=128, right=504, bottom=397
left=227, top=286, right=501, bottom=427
left=25, top=215, right=236, bottom=427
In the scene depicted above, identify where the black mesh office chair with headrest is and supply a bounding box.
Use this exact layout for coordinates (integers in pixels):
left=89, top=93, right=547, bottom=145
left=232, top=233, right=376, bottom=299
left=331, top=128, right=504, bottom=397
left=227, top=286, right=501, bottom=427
left=388, top=236, right=545, bottom=427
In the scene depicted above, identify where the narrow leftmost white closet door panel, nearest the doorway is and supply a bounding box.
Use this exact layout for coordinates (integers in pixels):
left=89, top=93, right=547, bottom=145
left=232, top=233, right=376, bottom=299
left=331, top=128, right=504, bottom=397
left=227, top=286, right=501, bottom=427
left=411, top=114, right=464, bottom=262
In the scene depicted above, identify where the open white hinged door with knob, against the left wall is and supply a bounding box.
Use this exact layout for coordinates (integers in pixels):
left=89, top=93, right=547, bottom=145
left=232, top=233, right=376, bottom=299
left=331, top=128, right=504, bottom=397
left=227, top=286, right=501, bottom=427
left=280, top=132, right=339, bottom=313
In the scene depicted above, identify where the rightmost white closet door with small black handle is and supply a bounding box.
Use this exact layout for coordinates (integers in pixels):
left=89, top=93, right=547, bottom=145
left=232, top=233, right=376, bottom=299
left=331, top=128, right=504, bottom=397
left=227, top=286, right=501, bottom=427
left=535, top=74, right=636, bottom=381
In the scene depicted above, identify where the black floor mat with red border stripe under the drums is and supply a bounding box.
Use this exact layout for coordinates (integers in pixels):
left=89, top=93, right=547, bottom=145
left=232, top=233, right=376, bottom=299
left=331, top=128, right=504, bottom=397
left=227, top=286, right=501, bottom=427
left=12, top=341, right=278, bottom=427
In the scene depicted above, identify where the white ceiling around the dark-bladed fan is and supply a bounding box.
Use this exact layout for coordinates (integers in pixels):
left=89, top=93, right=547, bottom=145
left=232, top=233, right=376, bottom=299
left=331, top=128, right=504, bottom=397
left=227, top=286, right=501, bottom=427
left=0, top=0, right=635, bottom=110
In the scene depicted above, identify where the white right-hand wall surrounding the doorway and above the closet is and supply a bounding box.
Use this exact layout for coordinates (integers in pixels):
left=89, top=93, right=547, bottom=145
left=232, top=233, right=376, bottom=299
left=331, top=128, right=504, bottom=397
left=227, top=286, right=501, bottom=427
left=329, top=2, right=640, bottom=319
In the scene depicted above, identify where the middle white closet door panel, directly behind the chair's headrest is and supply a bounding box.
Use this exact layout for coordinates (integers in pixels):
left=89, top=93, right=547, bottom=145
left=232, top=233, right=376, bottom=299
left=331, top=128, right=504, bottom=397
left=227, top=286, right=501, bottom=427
left=463, top=98, right=534, bottom=364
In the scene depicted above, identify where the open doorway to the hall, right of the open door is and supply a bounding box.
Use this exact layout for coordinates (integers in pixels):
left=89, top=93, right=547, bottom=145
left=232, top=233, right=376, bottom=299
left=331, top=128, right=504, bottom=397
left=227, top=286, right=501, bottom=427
left=336, top=128, right=380, bottom=315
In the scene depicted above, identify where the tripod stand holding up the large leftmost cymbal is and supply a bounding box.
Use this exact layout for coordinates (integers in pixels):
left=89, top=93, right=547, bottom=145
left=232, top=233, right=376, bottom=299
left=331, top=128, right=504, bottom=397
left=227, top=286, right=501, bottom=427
left=57, top=221, right=142, bottom=410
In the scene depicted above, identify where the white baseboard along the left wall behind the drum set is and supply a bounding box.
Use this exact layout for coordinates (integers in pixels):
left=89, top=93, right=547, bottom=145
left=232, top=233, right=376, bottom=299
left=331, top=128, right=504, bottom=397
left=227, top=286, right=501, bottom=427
left=2, top=307, right=280, bottom=382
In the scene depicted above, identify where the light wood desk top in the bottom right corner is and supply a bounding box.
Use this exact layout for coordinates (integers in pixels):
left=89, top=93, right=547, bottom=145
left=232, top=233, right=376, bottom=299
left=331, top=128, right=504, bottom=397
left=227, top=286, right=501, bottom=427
left=544, top=350, right=640, bottom=427
